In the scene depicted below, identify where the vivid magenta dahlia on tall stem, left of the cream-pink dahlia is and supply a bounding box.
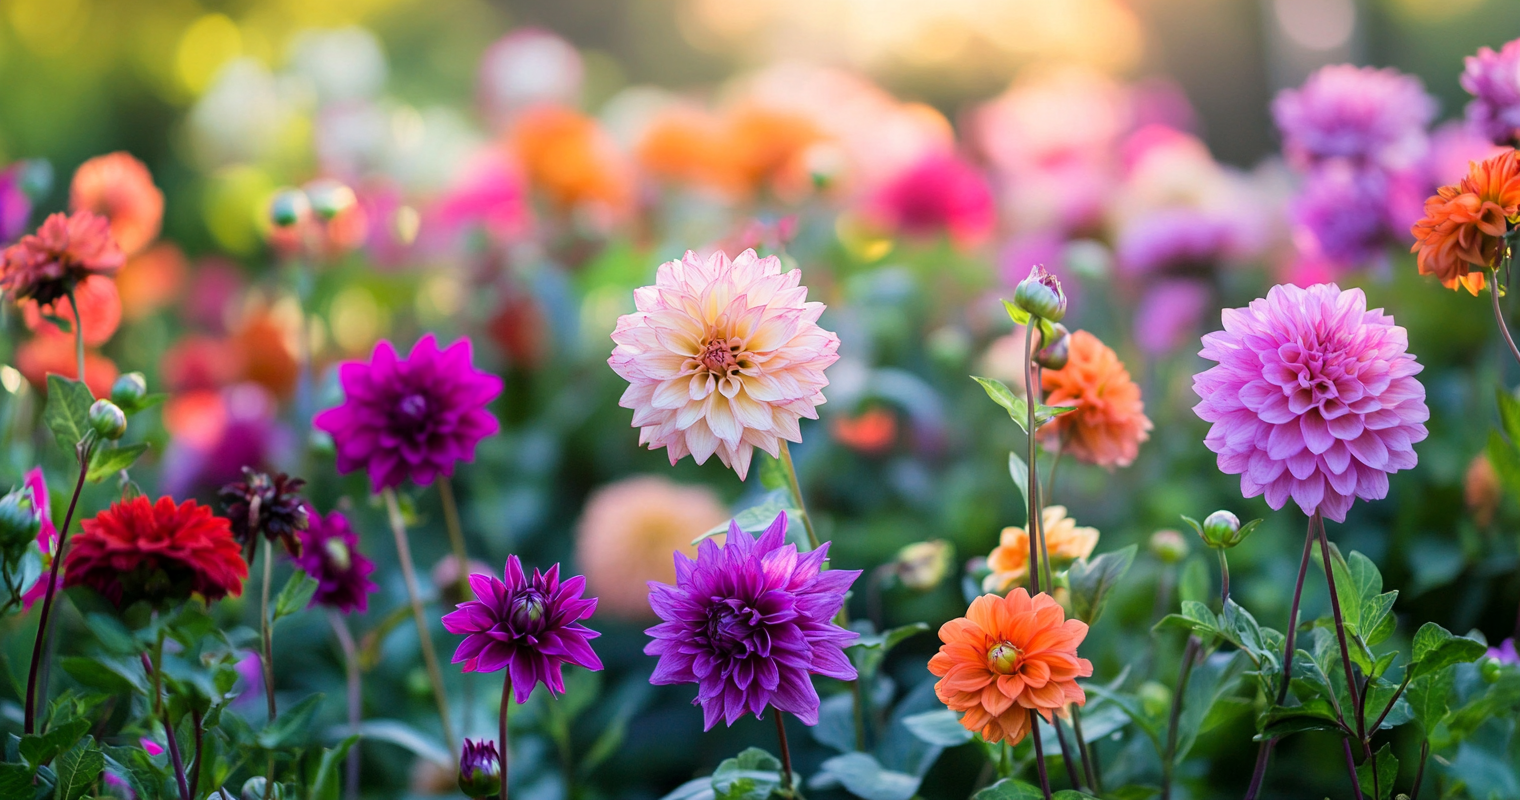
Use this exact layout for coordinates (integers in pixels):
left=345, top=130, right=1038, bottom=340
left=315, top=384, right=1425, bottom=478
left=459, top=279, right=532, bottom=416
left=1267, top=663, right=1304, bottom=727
left=312, top=333, right=502, bottom=491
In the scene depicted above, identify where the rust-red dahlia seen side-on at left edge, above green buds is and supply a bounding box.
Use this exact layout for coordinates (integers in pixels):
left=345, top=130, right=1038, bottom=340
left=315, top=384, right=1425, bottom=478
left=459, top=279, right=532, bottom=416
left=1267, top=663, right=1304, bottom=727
left=0, top=211, right=126, bottom=306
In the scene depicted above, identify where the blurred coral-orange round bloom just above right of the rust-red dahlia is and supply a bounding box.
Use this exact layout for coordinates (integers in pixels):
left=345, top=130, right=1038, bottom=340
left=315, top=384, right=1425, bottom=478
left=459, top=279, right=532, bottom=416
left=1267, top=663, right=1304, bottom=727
left=68, top=152, right=164, bottom=256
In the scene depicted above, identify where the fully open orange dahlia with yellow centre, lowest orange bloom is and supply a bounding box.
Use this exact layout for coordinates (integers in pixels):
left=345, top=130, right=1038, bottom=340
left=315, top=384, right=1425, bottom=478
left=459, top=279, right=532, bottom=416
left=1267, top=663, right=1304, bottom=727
left=929, top=589, right=1093, bottom=744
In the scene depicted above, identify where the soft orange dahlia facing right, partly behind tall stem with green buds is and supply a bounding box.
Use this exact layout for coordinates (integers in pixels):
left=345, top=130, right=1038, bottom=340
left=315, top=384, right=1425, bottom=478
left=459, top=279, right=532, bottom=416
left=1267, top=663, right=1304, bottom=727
left=1040, top=330, right=1152, bottom=468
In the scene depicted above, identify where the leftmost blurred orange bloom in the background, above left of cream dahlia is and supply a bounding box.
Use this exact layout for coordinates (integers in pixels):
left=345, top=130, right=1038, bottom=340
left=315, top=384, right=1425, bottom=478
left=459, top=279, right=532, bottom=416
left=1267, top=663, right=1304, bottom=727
left=511, top=105, right=632, bottom=213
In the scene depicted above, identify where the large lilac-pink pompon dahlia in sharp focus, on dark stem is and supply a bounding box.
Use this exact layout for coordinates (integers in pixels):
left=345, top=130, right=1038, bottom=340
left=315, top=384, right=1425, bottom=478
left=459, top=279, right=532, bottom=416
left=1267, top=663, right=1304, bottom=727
left=1193, top=283, right=1430, bottom=522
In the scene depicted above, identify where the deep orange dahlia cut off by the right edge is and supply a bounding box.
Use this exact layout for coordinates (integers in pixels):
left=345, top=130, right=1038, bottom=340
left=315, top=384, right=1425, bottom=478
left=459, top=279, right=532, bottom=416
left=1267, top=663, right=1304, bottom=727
left=1409, top=151, right=1520, bottom=295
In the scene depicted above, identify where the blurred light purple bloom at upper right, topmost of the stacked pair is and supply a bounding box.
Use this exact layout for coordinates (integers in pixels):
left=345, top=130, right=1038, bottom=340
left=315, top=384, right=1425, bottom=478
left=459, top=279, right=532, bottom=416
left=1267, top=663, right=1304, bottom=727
left=1272, top=64, right=1436, bottom=169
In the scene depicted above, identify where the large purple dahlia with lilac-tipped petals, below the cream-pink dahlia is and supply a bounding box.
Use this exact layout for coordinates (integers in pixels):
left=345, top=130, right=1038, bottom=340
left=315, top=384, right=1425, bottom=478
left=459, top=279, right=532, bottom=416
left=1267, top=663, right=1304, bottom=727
left=644, top=514, right=860, bottom=730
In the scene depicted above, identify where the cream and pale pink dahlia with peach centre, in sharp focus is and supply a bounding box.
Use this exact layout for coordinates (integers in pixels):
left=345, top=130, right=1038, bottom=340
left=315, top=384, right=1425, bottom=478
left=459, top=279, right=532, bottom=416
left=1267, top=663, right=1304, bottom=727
left=608, top=249, right=839, bottom=479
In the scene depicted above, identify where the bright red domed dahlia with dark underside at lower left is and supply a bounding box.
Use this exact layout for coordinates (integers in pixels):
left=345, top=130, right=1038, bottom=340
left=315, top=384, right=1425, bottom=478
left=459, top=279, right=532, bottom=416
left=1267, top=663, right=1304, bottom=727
left=64, top=497, right=248, bottom=608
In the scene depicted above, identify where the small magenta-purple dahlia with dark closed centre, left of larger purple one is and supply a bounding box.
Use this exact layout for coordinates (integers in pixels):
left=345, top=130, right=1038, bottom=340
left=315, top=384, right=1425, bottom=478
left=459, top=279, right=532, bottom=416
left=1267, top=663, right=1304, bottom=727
left=444, top=555, right=602, bottom=704
